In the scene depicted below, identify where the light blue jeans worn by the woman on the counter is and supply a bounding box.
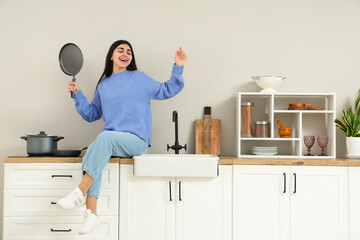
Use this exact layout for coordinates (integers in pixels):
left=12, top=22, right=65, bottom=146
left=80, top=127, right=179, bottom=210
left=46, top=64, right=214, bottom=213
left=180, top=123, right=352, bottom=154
left=81, top=131, right=148, bottom=198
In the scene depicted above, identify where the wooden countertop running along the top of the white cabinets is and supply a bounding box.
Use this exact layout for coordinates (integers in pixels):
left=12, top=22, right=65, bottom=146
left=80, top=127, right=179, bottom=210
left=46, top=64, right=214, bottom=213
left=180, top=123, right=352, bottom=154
left=5, top=156, right=360, bottom=167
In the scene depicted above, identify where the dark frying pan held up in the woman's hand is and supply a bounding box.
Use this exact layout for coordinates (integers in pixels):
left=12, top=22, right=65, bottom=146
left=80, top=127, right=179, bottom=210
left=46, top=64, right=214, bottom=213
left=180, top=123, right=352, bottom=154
left=59, top=43, right=84, bottom=98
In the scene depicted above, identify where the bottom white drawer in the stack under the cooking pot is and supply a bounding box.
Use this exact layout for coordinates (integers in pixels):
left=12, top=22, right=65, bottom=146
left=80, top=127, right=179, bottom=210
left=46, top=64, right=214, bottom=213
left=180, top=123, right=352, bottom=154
left=3, top=216, right=118, bottom=240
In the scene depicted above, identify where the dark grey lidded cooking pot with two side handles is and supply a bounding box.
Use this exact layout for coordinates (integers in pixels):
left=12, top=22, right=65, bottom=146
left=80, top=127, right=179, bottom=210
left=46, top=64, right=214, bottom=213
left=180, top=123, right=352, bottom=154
left=20, top=131, right=64, bottom=156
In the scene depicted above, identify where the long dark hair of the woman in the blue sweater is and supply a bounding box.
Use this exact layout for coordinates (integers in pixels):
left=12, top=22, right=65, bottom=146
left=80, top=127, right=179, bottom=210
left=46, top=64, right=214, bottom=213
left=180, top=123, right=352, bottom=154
left=95, top=40, right=137, bottom=91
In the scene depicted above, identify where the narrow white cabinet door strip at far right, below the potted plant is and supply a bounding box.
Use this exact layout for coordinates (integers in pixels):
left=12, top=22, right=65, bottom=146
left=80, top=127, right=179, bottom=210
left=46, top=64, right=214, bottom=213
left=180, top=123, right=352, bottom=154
left=349, top=167, right=360, bottom=240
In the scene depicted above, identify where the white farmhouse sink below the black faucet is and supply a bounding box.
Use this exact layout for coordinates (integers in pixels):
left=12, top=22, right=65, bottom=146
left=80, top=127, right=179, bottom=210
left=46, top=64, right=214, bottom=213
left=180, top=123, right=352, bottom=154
left=134, top=154, right=219, bottom=177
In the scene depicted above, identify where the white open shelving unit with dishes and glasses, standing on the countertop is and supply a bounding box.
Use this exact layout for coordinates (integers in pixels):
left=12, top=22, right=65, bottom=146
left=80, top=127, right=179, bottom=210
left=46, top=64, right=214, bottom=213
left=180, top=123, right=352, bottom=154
left=236, top=92, right=336, bottom=158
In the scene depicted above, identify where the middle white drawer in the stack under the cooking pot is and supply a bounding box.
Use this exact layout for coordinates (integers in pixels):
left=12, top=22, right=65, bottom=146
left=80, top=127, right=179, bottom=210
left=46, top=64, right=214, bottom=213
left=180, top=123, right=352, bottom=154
left=4, top=189, right=118, bottom=217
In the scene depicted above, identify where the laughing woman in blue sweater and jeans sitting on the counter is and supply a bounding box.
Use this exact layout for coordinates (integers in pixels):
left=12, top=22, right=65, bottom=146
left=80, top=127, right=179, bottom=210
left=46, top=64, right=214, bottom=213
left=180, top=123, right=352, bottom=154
left=57, top=40, right=187, bottom=234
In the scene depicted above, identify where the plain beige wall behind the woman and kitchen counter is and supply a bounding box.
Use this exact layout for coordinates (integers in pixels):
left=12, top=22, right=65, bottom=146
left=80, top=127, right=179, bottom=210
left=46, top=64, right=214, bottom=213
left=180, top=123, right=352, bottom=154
left=0, top=0, right=360, bottom=233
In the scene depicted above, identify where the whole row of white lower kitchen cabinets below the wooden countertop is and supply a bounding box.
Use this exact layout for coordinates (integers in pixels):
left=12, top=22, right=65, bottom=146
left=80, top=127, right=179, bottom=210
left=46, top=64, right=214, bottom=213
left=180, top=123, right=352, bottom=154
left=3, top=163, right=354, bottom=240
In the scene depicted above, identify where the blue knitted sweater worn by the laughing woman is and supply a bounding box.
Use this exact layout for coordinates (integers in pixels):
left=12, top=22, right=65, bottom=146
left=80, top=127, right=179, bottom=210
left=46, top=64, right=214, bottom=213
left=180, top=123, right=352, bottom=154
left=74, top=65, right=184, bottom=147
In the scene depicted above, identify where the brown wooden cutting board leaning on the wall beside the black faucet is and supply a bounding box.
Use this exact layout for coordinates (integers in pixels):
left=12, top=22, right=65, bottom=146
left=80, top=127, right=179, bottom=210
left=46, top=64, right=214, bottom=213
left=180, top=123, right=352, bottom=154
left=195, top=108, right=221, bottom=155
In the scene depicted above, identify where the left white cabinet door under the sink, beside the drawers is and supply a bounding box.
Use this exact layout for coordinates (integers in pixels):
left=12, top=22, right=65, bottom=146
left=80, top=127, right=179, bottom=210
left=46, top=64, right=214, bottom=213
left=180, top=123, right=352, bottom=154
left=119, top=164, right=175, bottom=240
